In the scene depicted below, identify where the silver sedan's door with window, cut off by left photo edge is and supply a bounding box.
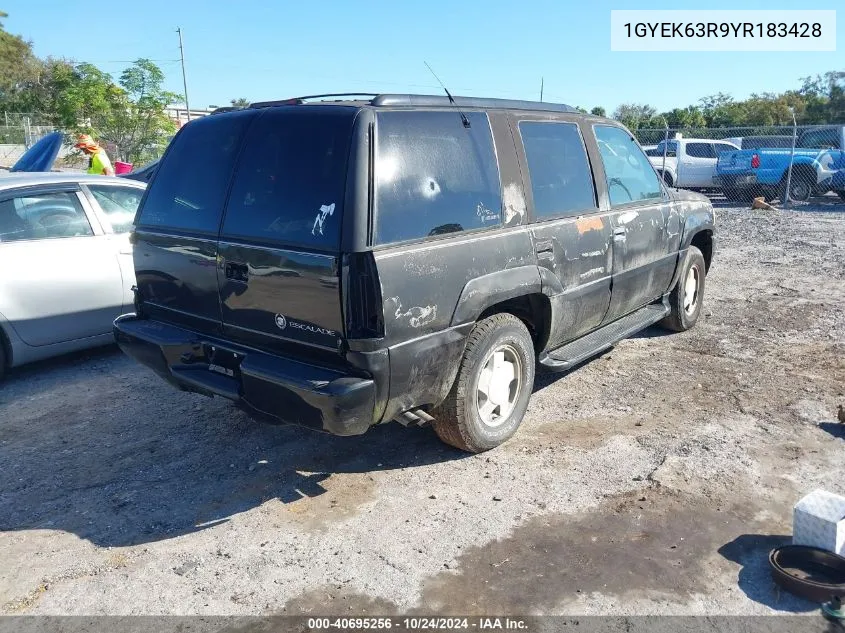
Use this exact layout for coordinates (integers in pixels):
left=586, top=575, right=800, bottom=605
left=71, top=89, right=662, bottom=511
left=0, top=184, right=122, bottom=346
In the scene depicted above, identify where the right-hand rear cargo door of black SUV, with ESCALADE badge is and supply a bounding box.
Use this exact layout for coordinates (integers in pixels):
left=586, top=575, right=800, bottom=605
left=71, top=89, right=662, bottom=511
left=218, top=106, right=357, bottom=353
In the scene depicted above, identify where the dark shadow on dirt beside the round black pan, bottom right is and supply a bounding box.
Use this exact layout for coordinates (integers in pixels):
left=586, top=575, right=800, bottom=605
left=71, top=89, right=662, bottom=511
left=719, top=534, right=819, bottom=613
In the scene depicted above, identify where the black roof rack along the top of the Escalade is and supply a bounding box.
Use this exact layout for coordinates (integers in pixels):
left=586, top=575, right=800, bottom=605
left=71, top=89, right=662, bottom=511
left=249, top=92, right=578, bottom=112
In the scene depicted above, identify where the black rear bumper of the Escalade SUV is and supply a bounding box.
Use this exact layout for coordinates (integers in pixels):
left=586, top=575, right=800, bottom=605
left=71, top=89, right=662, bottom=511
left=114, top=314, right=376, bottom=435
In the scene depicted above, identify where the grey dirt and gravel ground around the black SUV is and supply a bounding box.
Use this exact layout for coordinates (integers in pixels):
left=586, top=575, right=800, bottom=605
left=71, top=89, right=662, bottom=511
left=0, top=199, right=845, bottom=615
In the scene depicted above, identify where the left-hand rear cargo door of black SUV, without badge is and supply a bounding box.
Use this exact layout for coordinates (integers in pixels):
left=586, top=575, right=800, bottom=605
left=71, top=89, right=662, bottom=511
left=132, top=110, right=257, bottom=334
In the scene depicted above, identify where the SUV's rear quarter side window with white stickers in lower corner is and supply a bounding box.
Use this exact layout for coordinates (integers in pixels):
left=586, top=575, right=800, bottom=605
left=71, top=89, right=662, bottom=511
left=375, top=110, right=502, bottom=244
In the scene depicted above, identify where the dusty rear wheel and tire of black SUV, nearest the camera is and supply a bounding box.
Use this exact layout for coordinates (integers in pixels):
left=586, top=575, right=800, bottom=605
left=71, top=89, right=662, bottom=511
left=431, top=313, right=536, bottom=453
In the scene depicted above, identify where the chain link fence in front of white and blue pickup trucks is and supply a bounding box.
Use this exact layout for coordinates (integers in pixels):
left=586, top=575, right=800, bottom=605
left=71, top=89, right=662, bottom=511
left=634, top=123, right=845, bottom=204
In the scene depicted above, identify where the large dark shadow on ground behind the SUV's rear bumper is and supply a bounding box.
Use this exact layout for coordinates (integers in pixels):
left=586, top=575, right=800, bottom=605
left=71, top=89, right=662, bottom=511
left=0, top=351, right=468, bottom=546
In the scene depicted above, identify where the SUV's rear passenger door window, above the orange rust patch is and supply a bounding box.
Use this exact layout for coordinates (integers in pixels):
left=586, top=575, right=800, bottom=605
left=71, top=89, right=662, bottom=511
left=519, top=121, right=596, bottom=217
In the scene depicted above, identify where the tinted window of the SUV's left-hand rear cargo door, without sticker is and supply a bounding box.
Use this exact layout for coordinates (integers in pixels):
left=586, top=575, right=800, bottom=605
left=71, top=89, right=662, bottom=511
left=138, top=112, right=255, bottom=234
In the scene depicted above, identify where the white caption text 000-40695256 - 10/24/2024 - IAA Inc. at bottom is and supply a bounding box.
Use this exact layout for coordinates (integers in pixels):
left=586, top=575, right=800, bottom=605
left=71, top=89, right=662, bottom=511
left=307, top=617, right=528, bottom=631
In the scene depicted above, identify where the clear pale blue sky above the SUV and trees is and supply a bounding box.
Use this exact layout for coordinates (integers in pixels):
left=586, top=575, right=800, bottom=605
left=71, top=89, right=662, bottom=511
left=0, top=0, right=845, bottom=112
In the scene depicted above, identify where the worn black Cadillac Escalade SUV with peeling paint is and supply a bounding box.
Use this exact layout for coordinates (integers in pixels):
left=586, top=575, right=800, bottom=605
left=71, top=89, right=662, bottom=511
left=115, top=95, right=714, bottom=452
